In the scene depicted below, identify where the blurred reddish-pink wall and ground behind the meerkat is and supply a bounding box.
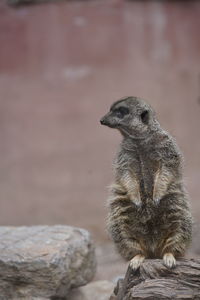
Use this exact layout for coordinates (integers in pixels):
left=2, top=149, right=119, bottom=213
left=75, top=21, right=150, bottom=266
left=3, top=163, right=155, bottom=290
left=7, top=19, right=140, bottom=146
left=0, top=0, right=200, bottom=279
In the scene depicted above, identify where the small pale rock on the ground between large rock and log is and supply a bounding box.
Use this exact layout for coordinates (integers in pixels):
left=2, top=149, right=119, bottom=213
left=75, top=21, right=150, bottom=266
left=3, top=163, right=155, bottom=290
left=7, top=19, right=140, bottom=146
left=69, top=280, right=114, bottom=300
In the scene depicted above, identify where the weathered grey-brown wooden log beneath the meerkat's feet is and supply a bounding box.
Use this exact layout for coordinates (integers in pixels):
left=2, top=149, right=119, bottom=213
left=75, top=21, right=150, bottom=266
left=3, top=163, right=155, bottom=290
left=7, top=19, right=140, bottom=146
left=110, top=259, right=200, bottom=300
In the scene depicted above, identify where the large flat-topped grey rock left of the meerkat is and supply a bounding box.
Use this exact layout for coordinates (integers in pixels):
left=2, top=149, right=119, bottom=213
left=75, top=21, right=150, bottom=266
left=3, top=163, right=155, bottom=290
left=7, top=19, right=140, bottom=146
left=0, top=225, right=96, bottom=300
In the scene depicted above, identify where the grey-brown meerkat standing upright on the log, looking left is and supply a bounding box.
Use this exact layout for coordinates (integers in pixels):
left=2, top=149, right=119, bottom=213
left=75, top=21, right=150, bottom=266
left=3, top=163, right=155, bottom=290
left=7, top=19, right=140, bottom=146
left=100, top=97, right=192, bottom=270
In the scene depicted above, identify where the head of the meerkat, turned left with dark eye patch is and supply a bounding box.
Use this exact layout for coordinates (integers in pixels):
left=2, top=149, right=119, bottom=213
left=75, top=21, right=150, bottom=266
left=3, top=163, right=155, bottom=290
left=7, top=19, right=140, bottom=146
left=100, top=97, right=156, bottom=137
